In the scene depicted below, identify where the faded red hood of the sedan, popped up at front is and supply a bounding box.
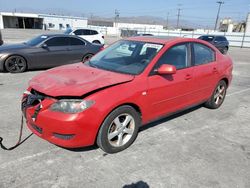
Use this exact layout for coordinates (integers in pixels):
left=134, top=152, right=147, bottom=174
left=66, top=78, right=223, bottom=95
left=29, top=63, right=134, bottom=97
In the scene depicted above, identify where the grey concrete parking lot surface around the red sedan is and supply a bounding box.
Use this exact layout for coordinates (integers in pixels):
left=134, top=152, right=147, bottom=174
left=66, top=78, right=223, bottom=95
left=0, top=48, right=250, bottom=188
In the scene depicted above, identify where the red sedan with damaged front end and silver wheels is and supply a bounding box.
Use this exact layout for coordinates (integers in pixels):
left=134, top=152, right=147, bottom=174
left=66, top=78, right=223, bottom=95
left=22, top=37, right=233, bottom=153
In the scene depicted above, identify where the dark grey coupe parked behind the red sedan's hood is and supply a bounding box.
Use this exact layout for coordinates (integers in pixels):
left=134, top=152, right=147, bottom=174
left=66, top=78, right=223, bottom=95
left=0, top=34, right=103, bottom=73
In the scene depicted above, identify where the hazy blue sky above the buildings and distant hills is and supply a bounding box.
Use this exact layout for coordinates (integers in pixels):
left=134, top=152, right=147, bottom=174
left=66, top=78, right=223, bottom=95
left=0, top=0, right=250, bottom=26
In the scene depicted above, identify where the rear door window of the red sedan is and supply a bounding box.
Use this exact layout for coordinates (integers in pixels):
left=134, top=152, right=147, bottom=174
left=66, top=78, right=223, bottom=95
left=193, top=43, right=215, bottom=65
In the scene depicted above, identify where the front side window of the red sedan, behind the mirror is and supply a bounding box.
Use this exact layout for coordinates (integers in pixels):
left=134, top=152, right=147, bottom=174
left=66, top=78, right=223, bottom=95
left=156, top=44, right=188, bottom=69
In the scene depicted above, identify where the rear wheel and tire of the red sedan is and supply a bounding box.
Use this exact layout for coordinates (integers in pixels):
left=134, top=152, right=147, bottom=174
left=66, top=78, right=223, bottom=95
left=205, top=80, right=227, bottom=109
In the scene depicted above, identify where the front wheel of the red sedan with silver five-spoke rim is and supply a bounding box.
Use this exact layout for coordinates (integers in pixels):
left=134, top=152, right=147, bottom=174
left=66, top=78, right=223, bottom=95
left=96, top=105, right=141, bottom=153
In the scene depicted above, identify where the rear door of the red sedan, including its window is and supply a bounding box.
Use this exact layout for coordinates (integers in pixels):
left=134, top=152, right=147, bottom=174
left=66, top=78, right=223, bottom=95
left=192, top=43, right=218, bottom=102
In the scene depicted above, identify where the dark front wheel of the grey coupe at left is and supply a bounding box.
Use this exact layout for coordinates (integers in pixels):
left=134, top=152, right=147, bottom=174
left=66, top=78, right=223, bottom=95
left=4, top=55, right=27, bottom=73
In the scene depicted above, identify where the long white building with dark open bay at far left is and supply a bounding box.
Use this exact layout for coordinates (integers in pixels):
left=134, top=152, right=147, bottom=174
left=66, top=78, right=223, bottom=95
left=0, top=12, right=88, bottom=30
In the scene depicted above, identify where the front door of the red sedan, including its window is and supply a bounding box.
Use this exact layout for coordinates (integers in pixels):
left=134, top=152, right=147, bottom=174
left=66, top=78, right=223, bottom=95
left=147, top=43, right=195, bottom=119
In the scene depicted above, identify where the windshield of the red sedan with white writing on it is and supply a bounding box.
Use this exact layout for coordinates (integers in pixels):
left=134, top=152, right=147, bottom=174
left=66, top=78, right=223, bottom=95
left=89, top=40, right=163, bottom=75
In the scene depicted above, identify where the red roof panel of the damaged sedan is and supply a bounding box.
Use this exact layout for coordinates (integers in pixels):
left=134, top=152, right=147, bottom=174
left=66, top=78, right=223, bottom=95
left=126, top=36, right=203, bottom=44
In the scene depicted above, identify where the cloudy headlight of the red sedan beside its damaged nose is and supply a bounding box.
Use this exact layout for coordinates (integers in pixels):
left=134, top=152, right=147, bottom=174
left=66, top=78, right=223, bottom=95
left=50, top=99, right=94, bottom=114
